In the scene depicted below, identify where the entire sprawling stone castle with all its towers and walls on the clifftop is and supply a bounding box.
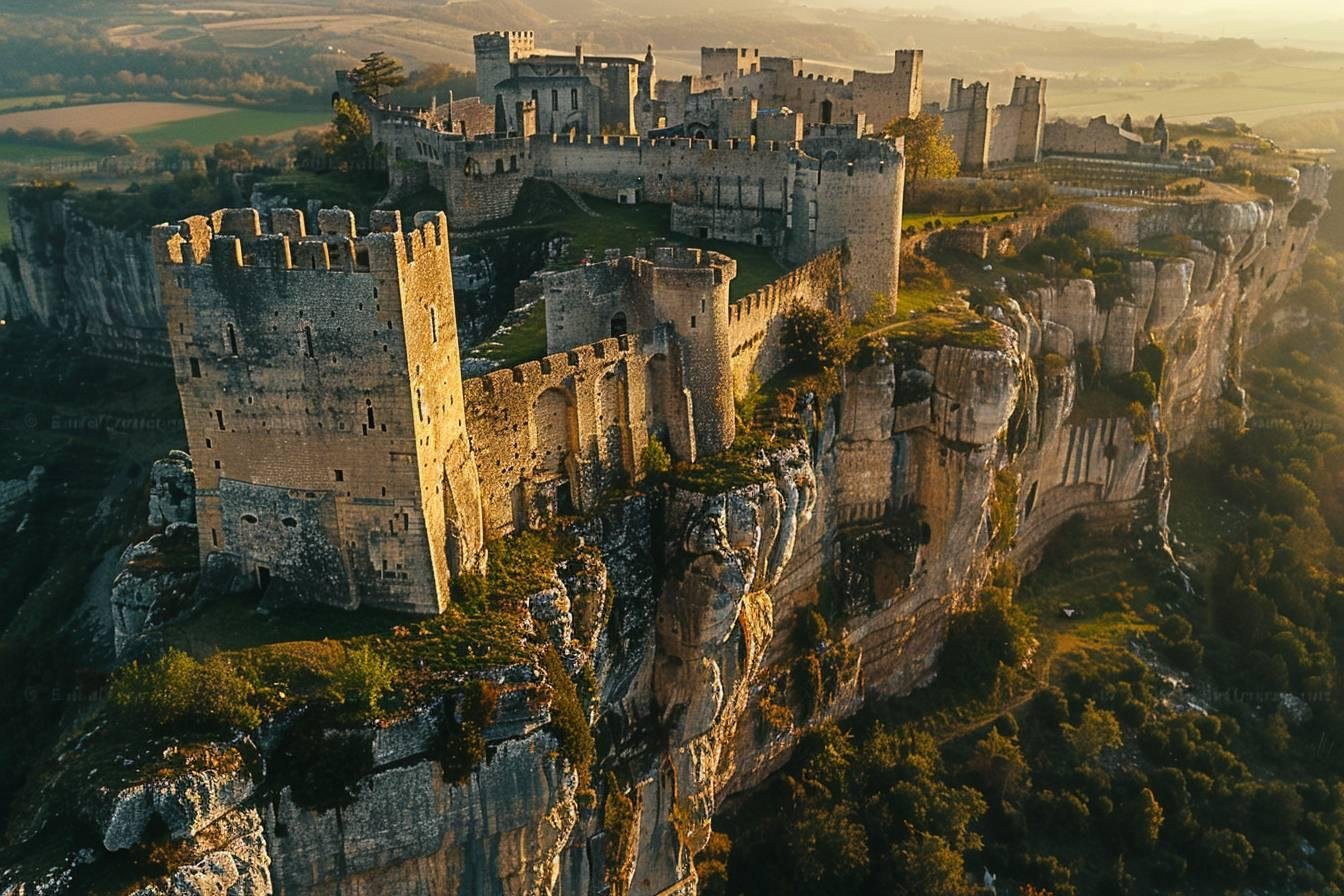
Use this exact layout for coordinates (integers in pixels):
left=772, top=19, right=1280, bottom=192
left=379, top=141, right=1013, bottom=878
left=144, top=31, right=1209, bottom=613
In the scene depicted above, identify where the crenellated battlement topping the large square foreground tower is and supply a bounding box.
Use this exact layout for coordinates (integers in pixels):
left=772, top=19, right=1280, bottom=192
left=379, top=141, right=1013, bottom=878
left=151, top=208, right=449, bottom=274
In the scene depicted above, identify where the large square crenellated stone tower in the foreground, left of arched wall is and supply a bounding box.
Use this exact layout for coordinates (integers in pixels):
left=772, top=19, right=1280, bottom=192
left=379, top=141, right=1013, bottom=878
left=153, top=208, right=484, bottom=614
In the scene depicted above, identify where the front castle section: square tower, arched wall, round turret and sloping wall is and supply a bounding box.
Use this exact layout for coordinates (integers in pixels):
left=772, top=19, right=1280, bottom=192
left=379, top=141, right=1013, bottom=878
left=153, top=208, right=845, bottom=613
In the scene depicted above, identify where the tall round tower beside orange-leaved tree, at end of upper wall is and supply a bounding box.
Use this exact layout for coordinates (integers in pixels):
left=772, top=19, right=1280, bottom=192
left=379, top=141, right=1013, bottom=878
left=788, top=138, right=906, bottom=317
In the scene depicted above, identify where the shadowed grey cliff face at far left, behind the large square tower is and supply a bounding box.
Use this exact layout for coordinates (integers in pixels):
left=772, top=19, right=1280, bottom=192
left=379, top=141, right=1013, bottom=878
left=0, top=188, right=168, bottom=360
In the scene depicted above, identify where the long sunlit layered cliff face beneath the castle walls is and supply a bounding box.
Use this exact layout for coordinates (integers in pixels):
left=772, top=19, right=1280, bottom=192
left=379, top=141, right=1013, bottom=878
left=0, top=167, right=1324, bottom=896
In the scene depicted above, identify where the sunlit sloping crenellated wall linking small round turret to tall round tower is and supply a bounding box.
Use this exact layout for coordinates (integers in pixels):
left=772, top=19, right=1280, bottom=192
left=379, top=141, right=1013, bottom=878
left=728, top=249, right=843, bottom=395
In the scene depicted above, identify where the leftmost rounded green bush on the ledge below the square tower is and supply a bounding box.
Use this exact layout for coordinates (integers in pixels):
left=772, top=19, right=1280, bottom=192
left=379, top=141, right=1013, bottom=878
left=109, top=649, right=261, bottom=732
